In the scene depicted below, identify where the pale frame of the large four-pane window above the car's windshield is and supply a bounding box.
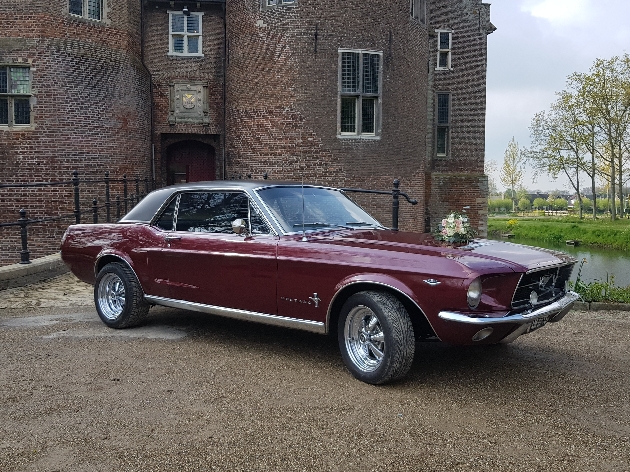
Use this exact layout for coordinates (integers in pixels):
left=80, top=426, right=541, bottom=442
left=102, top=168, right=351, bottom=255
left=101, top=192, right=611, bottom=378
left=337, top=48, right=383, bottom=139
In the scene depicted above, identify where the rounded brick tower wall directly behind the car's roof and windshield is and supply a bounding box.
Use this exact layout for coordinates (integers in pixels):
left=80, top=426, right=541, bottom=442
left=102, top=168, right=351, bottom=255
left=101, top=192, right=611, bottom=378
left=226, top=0, right=427, bottom=229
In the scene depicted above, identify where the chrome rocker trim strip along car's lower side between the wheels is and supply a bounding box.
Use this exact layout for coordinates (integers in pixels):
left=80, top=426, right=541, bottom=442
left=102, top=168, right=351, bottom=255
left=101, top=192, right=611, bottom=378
left=144, top=295, right=326, bottom=334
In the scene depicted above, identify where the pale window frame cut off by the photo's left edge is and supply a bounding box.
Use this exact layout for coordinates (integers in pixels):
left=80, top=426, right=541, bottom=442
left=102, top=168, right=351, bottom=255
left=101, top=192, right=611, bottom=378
left=0, top=63, right=33, bottom=130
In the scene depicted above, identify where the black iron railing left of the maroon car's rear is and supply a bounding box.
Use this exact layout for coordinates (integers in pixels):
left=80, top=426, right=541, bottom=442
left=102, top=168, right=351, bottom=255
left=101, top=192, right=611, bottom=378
left=0, top=170, right=155, bottom=264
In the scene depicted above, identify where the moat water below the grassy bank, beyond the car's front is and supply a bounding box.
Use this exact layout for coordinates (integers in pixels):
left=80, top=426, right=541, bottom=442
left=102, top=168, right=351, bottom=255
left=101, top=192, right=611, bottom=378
left=496, top=238, right=630, bottom=287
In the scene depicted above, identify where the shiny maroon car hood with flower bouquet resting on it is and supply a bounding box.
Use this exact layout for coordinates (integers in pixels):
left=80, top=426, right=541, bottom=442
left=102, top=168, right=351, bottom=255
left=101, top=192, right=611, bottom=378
left=298, top=230, right=576, bottom=272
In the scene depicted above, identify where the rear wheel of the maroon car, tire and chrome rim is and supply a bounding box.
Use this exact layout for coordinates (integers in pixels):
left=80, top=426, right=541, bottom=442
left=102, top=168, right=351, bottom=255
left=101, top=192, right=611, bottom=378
left=94, top=262, right=149, bottom=328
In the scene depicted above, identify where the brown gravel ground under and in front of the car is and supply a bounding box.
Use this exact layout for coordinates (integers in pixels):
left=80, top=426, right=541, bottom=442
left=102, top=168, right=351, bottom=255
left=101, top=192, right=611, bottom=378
left=0, top=275, right=630, bottom=472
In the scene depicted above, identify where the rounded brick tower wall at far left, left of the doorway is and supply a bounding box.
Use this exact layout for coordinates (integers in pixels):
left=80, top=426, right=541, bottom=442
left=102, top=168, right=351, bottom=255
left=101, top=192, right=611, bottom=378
left=0, top=0, right=150, bottom=264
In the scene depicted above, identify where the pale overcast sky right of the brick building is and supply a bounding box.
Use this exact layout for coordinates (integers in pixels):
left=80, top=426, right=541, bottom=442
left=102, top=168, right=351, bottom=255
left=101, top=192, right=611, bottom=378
left=486, top=0, right=630, bottom=191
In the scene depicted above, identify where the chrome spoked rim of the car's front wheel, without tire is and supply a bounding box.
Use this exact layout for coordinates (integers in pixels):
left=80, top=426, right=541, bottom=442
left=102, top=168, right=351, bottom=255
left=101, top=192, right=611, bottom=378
left=343, top=305, right=386, bottom=372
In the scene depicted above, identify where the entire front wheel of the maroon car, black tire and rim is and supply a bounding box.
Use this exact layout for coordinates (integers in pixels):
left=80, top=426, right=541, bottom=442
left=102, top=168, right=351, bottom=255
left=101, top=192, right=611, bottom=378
left=337, top=291, right=416, bottom=384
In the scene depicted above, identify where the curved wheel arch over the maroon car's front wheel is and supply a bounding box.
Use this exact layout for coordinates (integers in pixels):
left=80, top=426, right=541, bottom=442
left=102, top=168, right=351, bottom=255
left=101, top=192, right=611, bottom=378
left=326, top=277, right=436, bottom=340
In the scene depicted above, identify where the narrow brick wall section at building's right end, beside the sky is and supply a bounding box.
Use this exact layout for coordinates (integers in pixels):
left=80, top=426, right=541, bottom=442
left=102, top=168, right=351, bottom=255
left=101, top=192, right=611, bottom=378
left=426, top=0, right=492, bottom=236
